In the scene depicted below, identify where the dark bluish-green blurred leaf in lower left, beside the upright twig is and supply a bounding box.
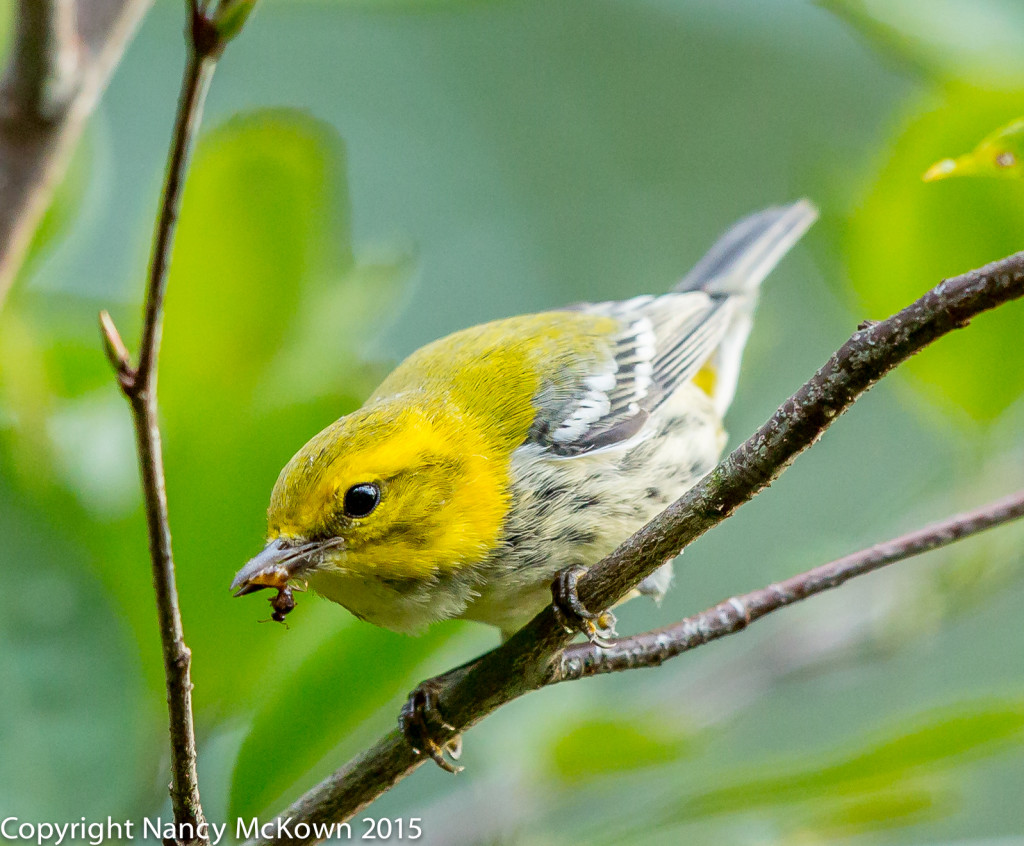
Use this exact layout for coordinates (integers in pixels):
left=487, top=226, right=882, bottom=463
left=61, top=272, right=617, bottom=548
left=0, top=469, right=149, bottom=819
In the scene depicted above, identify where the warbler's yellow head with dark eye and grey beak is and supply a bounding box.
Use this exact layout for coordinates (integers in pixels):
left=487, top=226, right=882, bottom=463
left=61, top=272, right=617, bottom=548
left=233, top=404, right=509, bottom=593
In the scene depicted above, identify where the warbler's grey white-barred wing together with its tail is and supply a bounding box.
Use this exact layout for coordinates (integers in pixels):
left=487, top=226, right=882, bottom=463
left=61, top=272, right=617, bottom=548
left=530, top=200, right=817, bottom=456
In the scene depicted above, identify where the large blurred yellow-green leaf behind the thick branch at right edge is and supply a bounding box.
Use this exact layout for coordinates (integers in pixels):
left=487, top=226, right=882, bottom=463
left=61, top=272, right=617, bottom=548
left=847, top=87, right=1024, bottom=425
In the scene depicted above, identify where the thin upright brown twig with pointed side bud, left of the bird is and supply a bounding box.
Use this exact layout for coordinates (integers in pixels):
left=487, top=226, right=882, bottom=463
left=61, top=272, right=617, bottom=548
left=99, top=0, right=228, bottom=844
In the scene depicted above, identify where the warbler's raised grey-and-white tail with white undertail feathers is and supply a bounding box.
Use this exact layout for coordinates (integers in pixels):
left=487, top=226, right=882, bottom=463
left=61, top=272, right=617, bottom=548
left=675, top=200, right=818, bottom=415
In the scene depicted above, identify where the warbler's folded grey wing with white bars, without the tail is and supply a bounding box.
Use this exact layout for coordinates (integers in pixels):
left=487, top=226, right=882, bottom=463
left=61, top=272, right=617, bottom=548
left=529, top=291, right=732, bottom=457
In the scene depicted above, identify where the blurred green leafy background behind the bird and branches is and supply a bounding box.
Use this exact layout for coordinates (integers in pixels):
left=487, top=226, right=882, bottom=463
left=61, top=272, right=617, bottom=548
left=0, top=0, right=1024, bottom=846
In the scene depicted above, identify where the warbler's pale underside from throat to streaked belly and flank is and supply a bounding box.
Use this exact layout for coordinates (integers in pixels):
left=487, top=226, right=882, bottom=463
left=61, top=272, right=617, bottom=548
left=309, top=385, right=726, bottom=634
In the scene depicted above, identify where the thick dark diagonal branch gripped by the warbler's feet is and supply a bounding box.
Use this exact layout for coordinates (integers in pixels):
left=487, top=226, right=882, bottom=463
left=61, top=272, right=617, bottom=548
left=251, top=246, right=1024, bottom=844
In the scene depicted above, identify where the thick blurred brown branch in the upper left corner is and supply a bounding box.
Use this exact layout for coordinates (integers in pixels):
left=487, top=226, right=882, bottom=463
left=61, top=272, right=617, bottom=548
left=0, top=0, right=153, bottom=306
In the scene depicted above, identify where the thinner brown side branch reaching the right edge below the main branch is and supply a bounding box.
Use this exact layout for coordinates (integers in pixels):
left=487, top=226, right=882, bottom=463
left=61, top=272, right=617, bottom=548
left=548, top=491, right=1024, bottom=684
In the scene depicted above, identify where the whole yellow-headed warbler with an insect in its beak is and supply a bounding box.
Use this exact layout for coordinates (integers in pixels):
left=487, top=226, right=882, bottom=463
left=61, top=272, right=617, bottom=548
left=231, top=200, right=817, bottom=637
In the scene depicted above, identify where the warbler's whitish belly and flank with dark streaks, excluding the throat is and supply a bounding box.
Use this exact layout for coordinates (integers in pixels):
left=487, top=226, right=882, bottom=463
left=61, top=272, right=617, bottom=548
left=461, top=385, right=726, bottom=632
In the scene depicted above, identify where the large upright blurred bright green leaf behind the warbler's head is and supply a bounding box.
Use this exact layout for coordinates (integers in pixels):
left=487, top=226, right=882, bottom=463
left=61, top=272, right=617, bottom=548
left=146, top=110, right=408, bottom=714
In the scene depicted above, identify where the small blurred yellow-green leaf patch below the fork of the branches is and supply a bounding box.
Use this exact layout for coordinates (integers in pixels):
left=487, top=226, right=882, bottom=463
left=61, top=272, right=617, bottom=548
left=551, top=715, right=691, bottom=784
